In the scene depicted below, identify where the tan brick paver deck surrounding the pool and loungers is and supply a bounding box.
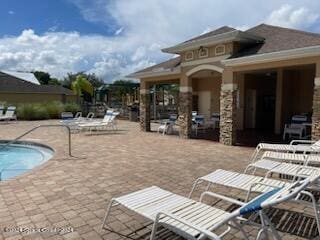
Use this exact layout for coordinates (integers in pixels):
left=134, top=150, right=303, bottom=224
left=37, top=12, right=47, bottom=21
left=0, top=121, right=316, bottom=240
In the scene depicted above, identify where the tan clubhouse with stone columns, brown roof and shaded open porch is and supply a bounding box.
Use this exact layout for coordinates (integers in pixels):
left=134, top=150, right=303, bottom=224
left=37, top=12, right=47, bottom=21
left=129, top=24, right=320, bottom=145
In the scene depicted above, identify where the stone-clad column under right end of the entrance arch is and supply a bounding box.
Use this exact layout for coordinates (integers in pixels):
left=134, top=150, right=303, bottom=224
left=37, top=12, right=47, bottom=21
left=220, top=70, right=237, bottom=145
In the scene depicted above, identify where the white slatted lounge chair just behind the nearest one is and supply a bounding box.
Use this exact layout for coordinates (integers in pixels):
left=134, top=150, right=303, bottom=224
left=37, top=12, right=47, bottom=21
left=189, top=169, right=320, bottom=234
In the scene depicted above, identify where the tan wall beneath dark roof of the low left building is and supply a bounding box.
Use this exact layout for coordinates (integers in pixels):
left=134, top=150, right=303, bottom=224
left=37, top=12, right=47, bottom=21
left=0, top=93, right=76, bottom=103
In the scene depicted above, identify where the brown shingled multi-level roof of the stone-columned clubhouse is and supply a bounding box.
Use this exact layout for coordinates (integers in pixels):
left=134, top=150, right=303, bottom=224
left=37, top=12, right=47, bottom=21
left=128, top=24, right=320, bottom=78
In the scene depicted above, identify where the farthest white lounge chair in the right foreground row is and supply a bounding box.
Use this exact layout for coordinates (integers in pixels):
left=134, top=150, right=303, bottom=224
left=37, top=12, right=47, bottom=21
left=251, top=140, right=320, bottom=161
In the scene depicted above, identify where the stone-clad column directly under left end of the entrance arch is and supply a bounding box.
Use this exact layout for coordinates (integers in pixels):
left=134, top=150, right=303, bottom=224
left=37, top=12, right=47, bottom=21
left=177, top=76, right=192, bottom=138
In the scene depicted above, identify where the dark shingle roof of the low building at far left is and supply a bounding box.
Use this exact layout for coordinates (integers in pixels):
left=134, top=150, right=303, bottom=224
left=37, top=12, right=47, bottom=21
left=0, top=72, right=74, bottom=95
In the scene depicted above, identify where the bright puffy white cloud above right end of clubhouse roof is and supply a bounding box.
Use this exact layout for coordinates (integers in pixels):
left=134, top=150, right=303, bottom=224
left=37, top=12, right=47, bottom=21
left=266, top=4, right=319, bottom=28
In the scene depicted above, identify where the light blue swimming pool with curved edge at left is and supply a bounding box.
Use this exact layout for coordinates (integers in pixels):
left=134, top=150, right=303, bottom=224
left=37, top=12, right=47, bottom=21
left=0, top=142, right=54, bottom=180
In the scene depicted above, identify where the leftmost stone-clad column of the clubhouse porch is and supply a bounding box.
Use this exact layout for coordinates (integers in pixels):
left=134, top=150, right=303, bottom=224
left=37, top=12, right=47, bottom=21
left=140, top=80, right=150, bottom=132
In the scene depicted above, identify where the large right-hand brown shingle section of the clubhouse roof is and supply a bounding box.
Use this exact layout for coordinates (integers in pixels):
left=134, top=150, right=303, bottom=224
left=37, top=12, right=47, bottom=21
left=233, top=24, right=320, bottom=58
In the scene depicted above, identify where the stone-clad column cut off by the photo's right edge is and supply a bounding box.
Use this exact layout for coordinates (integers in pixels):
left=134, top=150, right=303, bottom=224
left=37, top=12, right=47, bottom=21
left=312, top=61, right=320, bottom=141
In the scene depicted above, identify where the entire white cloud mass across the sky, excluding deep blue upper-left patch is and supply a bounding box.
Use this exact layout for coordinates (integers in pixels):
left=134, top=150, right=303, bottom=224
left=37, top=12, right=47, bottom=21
left=0, top=0, right=320, bottom=81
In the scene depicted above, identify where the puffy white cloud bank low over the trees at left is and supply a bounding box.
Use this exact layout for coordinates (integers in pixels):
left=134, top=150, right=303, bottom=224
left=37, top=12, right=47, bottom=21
left=0, top=29, right=154, bottom=80
